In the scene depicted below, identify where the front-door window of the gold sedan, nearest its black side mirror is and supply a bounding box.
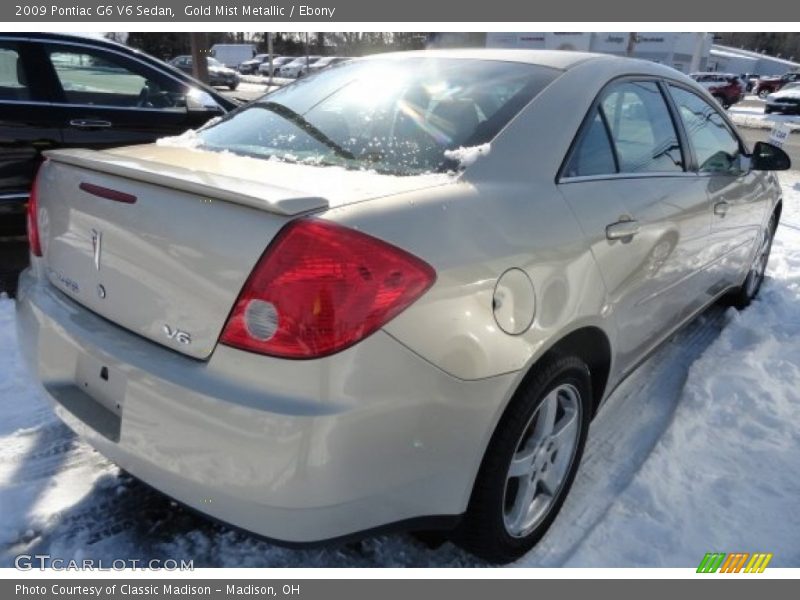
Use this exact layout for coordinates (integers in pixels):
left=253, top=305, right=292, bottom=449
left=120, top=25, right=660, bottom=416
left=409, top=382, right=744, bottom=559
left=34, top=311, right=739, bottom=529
left=669, top=85, right=741, bottom=174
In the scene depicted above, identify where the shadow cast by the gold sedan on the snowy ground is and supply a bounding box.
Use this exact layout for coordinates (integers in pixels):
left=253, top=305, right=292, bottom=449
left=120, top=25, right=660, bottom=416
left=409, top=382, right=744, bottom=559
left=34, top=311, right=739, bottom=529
left=0, top=290, right=760, bottom=568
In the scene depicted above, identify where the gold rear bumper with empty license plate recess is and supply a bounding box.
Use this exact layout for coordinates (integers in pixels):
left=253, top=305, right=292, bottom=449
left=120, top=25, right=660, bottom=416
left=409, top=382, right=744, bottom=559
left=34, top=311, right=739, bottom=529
left=17, top=265, right=515, bottom=543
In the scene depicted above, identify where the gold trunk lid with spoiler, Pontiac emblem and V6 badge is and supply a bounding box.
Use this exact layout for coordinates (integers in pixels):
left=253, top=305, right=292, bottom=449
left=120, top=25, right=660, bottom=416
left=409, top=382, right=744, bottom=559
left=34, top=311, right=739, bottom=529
left=38, top=146, right=450, bottom=359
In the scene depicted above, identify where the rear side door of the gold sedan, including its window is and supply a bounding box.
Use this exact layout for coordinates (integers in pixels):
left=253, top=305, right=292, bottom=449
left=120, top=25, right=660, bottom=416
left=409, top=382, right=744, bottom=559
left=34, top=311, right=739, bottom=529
left=560, top=80, right=710, bottom=369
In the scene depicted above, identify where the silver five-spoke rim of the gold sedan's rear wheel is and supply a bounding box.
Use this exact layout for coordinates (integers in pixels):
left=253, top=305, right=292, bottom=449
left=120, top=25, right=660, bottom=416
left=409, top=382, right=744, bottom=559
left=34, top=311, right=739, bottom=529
left=503, top=384, right=582, bottom=537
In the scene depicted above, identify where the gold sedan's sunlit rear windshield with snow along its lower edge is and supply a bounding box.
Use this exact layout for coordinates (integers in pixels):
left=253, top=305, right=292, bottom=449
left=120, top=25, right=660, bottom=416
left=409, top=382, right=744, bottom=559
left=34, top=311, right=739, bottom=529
left=199, top=58, right=559, bottom=175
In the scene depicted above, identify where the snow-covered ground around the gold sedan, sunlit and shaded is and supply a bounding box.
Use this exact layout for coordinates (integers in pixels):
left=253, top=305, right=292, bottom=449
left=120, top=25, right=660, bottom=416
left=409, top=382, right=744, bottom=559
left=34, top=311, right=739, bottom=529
left=0, top=171, right=800, bottom=567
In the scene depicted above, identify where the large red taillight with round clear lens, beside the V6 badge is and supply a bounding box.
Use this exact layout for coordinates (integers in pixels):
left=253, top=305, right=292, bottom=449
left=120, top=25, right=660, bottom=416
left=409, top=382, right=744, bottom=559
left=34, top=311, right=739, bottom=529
left=220, top=219, right=436, bottom=358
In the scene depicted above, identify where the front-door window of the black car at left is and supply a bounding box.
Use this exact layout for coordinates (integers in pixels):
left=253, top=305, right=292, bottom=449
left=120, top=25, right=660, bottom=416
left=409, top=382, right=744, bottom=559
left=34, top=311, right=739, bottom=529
left=47, top=45, right=186, bottom=109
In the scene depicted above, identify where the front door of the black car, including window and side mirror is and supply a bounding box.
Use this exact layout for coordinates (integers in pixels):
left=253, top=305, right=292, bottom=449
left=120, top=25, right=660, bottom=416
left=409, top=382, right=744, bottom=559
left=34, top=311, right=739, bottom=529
left=37, top=43, right=219, bottom=148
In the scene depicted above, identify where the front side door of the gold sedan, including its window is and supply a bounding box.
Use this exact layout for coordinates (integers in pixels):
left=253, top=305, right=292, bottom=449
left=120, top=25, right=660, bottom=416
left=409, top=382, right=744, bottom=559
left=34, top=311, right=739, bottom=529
left=668, top=84, right=767, bottom=287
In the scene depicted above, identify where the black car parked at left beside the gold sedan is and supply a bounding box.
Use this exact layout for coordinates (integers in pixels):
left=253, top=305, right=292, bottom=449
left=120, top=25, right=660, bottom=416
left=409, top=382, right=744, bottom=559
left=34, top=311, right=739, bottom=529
left=0, top=33, right=237, bottom=294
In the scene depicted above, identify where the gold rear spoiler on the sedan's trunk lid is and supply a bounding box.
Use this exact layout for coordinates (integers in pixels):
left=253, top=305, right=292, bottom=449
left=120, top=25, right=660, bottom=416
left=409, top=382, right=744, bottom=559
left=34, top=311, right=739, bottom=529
left=43, top=149, right=329, bottom=216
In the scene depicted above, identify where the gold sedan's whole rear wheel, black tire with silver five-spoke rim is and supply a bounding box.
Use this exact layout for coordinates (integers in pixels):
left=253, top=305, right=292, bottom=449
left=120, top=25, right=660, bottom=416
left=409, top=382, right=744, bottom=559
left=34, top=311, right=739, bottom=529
left=453, top=356, right=592, bottom=563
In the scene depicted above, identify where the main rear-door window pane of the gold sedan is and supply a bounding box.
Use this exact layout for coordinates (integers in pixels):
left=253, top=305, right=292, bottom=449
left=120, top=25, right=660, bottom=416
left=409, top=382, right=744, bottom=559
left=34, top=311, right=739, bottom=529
left=600, top=81, right=683, bottom=173
